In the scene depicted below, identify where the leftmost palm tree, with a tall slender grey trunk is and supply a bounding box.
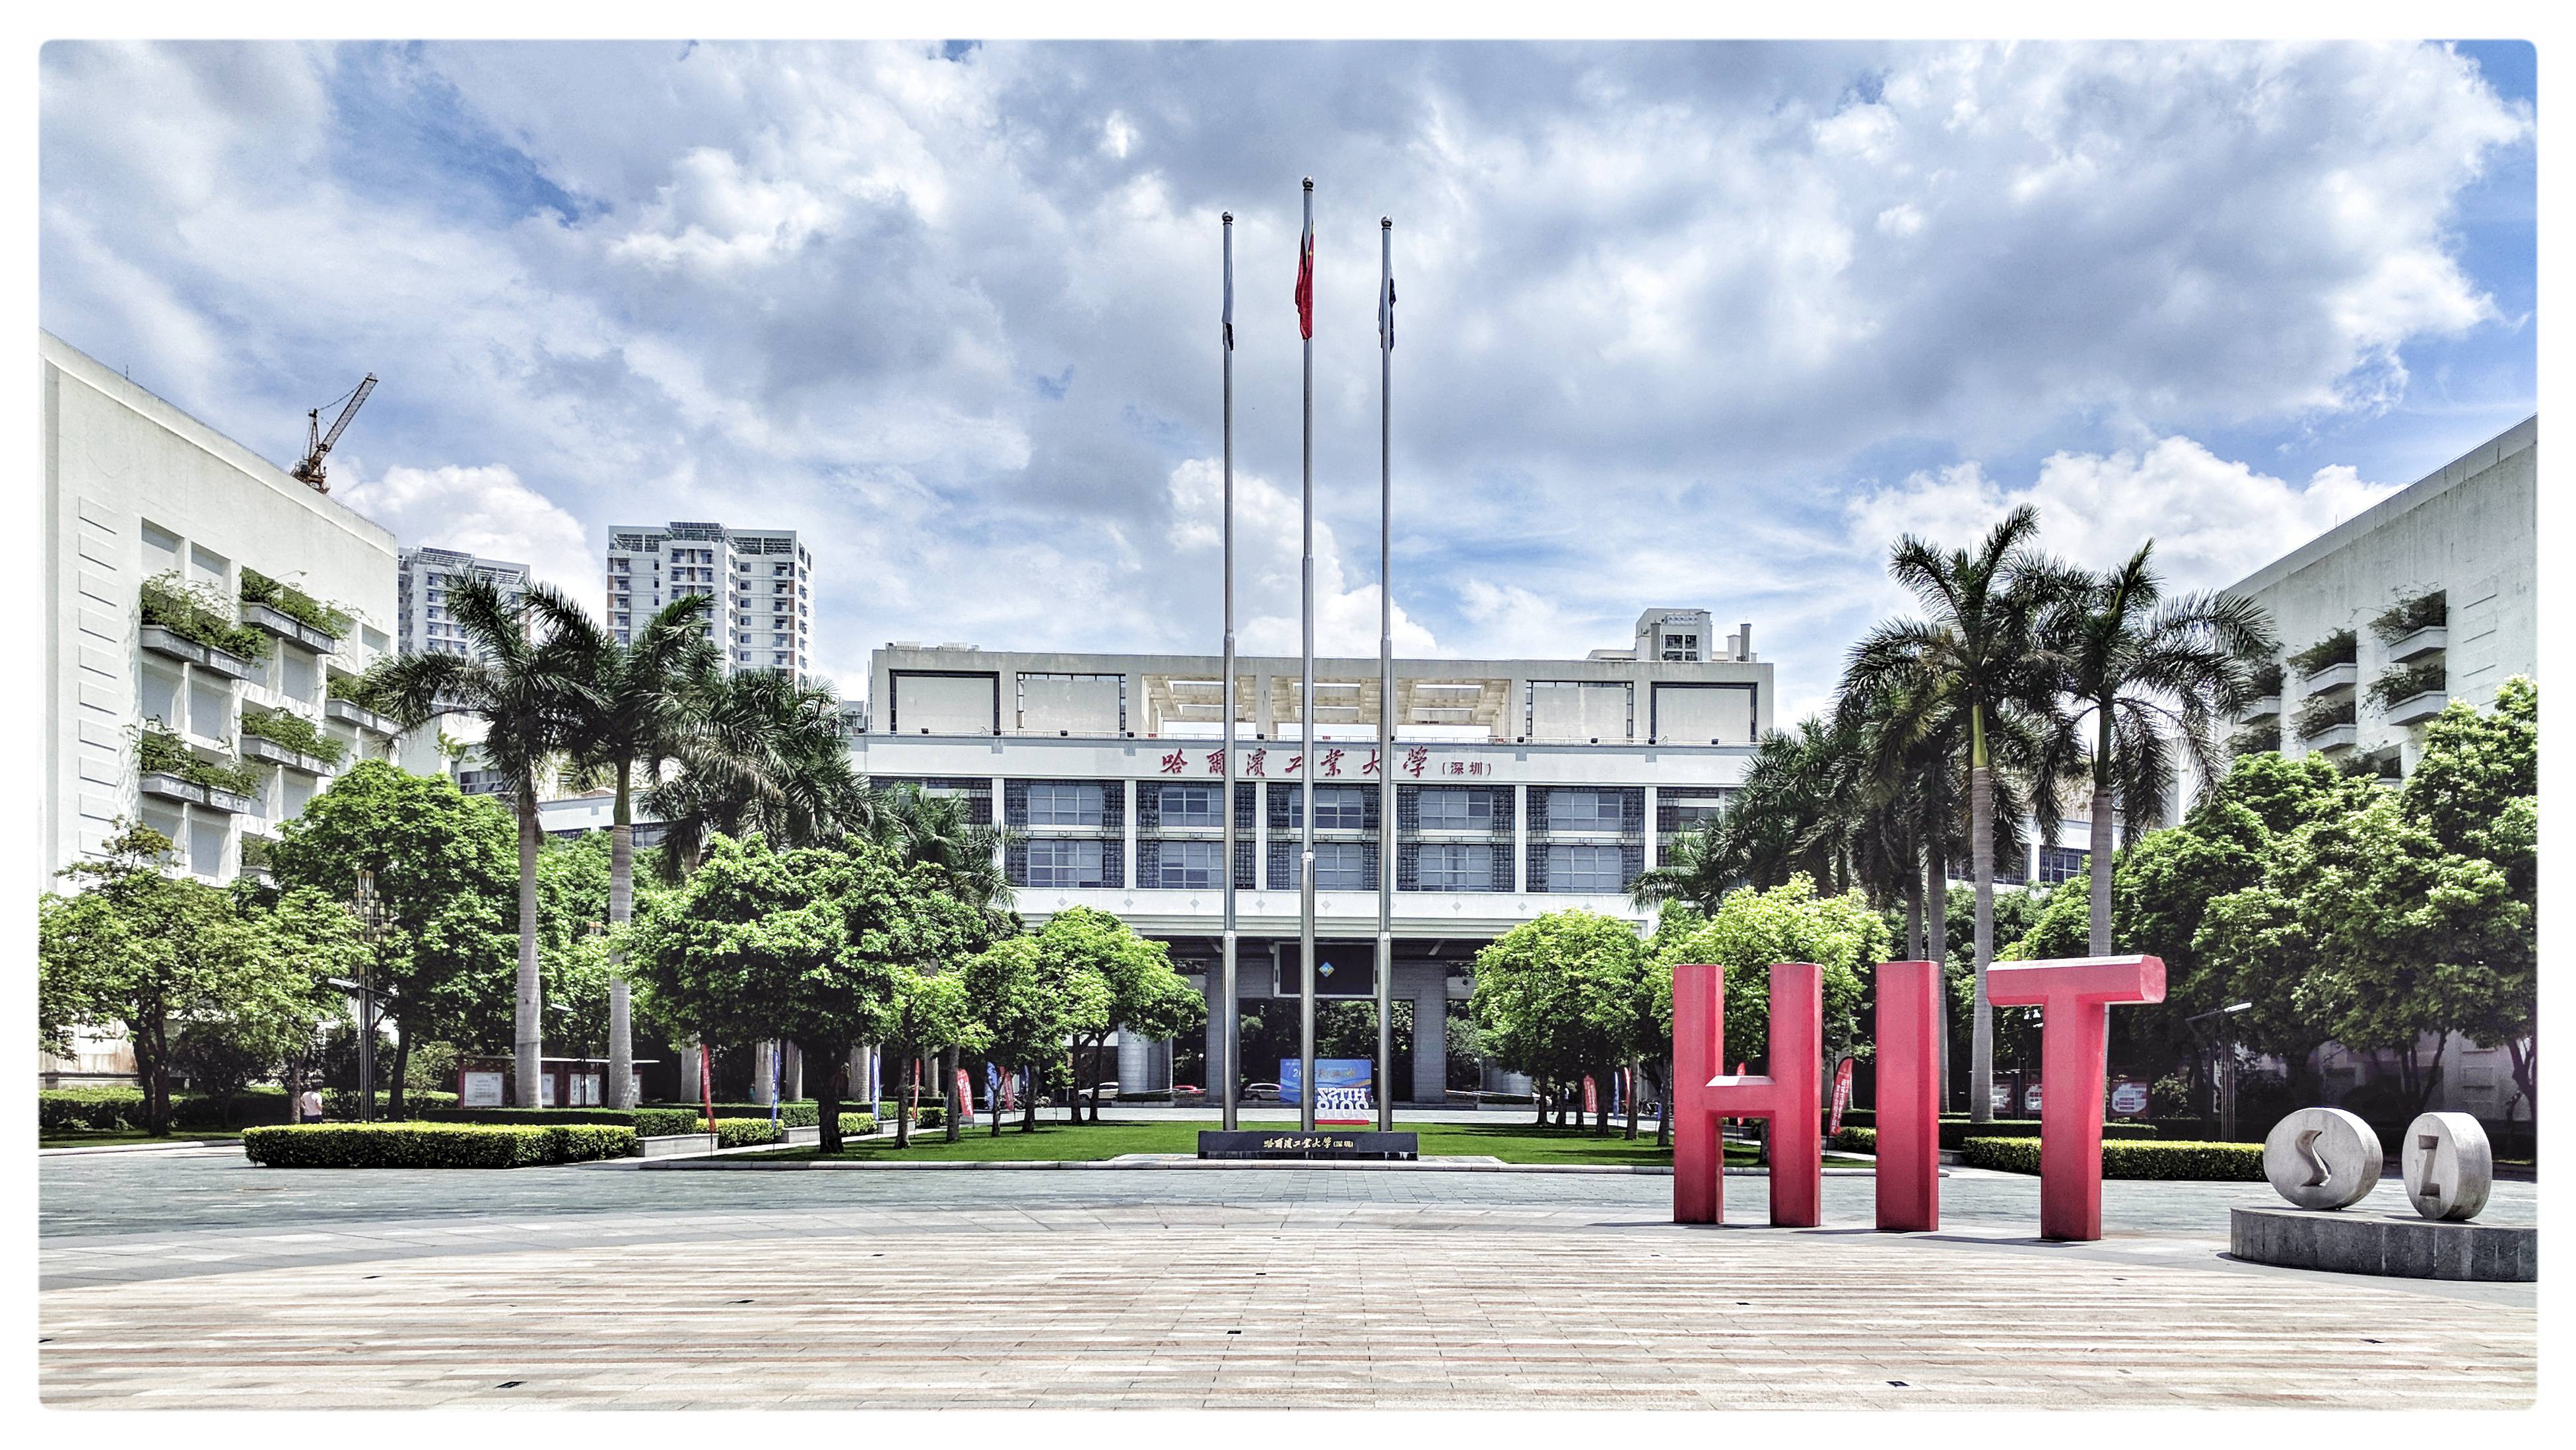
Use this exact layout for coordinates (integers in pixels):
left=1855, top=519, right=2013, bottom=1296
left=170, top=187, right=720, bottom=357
left=360, top=580, right=592, bottom=1107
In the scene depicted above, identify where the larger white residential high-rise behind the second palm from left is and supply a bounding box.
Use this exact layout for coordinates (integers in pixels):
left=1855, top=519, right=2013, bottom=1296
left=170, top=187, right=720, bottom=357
left=608, top=523, right=814, bottom=680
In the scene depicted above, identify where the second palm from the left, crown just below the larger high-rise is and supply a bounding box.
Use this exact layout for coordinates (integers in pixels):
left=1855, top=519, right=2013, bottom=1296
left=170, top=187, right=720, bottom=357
left=572, top=595, right=722, bottom=1107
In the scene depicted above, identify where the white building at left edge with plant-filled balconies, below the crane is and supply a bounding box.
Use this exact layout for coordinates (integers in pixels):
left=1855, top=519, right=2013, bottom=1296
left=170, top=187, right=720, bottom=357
left=36, top=332, right=422, bottom=1079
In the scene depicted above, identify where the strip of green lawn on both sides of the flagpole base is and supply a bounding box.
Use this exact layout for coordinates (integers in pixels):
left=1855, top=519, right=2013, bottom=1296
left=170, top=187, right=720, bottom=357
left=757, top=1123, right=1862, bottom=1167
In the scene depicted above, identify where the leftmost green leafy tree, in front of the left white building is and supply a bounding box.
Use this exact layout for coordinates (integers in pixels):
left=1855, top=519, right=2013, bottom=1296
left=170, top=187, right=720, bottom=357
left=36, top=827, right=353, bottom=1136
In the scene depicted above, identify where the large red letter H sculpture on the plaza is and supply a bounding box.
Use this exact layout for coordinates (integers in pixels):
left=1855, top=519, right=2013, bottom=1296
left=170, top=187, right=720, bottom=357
left=1672, top=961, right=1824, bottom=1229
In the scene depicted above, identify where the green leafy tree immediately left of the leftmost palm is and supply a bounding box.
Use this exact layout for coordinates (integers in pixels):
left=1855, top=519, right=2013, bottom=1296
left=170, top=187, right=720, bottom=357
left=268, top=760, right=525, bottom=1113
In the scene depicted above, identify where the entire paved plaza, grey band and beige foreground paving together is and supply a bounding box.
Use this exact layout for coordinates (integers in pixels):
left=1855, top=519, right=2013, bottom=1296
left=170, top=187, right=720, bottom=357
left=39, top=1149, right=2537, bottom=1409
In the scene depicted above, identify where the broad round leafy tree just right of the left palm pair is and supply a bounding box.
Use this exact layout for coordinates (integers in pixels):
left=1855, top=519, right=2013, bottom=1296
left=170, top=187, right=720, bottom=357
left=626, top=837, right=986, bottom=1152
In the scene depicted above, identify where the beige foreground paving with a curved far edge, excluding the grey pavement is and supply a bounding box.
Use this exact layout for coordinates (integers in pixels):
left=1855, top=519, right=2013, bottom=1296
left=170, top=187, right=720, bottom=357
left=39, top=1205, right=2537, bottom=1409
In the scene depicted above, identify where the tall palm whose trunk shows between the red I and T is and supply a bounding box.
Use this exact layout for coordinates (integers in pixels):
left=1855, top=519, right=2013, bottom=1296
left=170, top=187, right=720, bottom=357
left=1842, top=505, right=2068, bottom=1123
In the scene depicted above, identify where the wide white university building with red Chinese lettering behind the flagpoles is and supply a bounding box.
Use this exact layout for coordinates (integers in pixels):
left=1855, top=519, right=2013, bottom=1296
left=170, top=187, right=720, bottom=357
left=850, top=608, right=1773, bottom=1102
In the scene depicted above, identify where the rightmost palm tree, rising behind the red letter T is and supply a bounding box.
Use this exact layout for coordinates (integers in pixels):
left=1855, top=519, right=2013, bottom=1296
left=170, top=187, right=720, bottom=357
left=2048, top=538, right=2274, bottom=955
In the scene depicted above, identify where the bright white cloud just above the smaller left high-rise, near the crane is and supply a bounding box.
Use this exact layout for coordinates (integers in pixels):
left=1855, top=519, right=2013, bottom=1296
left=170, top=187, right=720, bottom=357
left=335, top=464, right=600, bottom=602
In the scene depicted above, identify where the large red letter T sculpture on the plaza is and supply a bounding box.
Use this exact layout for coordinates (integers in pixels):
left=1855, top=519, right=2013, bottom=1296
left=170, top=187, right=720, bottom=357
left=1978, top=955, right=2164, bottom=1239
